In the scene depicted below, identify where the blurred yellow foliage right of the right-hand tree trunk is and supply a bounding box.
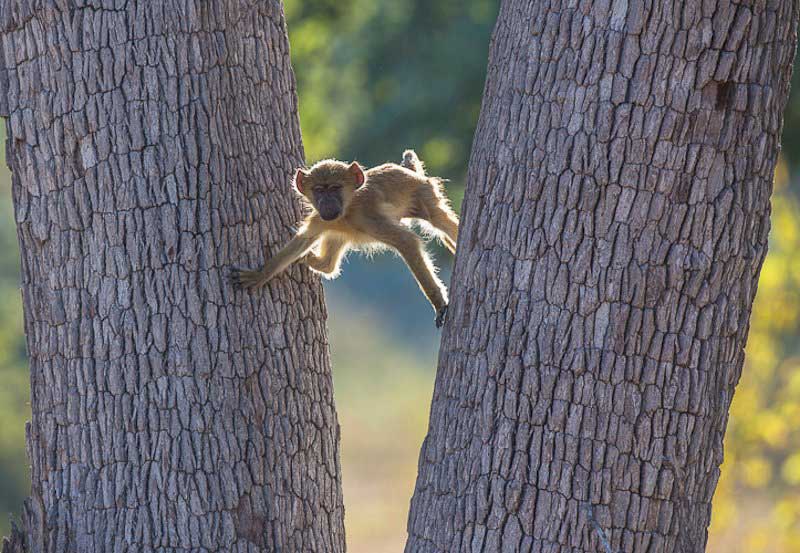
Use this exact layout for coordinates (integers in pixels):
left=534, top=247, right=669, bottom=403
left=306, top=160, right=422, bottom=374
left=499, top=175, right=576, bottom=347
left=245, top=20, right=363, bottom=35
left=708, top=160, right=800, bottom=553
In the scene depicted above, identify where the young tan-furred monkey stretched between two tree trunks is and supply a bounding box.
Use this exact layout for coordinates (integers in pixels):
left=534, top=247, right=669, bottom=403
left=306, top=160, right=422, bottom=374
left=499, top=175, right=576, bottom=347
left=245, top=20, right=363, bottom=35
left=228, top=150, right=458, bottom=325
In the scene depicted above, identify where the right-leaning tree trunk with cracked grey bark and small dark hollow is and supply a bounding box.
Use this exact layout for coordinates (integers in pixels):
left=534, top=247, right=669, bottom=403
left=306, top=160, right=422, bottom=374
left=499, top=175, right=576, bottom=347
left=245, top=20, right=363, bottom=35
left=406, top=0, right=798, bottom=552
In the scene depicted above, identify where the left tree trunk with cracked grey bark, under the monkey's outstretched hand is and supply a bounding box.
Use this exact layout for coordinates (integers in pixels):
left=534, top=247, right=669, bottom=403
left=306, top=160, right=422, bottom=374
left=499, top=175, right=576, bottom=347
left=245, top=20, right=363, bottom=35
left=0, top=0, right=344, bottom=553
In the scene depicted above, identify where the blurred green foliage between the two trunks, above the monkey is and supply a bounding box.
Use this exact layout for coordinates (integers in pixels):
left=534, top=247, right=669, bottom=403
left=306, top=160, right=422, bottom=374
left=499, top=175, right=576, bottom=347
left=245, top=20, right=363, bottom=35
left=286, top=0, right=498, bottom=204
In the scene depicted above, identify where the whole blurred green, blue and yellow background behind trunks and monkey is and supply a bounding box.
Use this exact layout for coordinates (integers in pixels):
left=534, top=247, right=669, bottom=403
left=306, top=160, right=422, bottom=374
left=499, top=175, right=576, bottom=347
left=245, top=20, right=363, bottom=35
left=0, top=0, right=800, bottom=553
